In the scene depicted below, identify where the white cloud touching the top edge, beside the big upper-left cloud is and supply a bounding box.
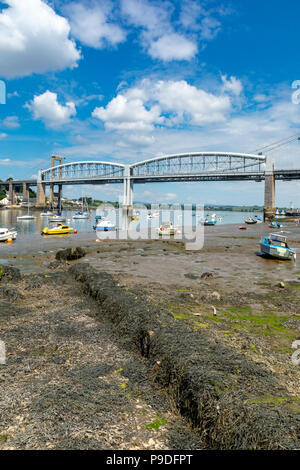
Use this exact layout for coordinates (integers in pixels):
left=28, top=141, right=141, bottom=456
left=65, top=2, right=126, bottom=49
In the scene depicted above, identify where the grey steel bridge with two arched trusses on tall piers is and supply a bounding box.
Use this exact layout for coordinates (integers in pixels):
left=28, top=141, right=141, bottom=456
left=6, top=152, right=300, bottom=217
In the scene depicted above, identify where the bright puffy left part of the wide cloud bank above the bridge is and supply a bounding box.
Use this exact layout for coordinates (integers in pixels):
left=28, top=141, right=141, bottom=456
left=93, top=90, right=162, bottom=131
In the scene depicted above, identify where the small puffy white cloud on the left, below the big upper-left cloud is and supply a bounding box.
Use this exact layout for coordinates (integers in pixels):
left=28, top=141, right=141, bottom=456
left=26, top=90, right=76, bottom=128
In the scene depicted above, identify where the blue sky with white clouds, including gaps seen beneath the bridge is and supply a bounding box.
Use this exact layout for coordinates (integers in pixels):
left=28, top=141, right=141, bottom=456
left=0, top=0, right=300, bottom=206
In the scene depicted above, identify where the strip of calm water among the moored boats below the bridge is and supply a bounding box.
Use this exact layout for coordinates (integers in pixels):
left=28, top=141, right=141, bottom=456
left=0, top=209, right=263, bottom=238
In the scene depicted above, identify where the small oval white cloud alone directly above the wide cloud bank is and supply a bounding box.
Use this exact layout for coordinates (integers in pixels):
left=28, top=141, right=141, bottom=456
left=149, top=33, right=198, bottom=61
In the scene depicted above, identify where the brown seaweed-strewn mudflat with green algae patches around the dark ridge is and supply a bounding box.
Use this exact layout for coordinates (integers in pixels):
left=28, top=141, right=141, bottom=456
left=0, top=224, right=300, bottom=449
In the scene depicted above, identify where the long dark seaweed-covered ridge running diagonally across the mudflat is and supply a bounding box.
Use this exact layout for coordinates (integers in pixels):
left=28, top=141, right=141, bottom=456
left=69, top=263, right=300, bottom=450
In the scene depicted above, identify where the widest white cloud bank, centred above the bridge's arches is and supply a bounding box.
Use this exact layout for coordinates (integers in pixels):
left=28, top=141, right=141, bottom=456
left=93, top=77, right=237, bottom=131
